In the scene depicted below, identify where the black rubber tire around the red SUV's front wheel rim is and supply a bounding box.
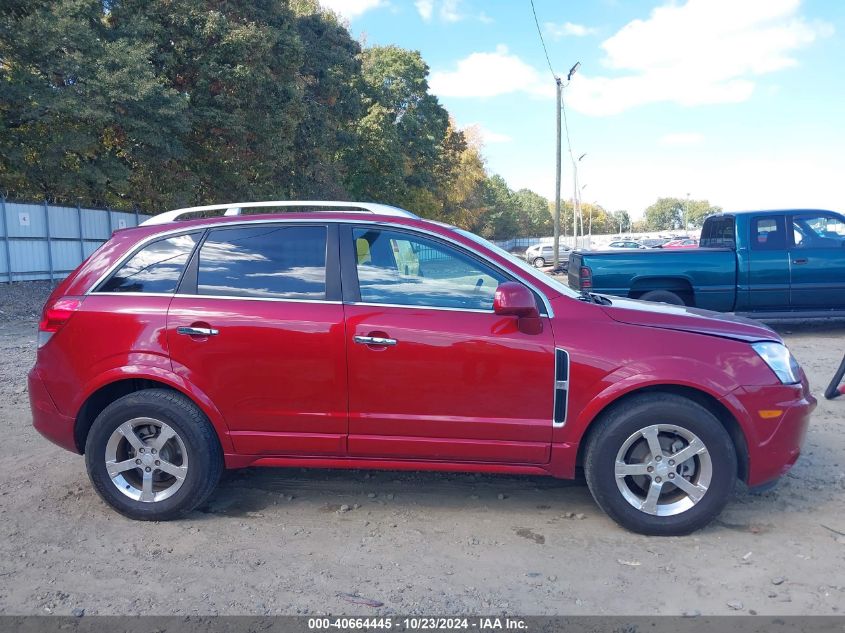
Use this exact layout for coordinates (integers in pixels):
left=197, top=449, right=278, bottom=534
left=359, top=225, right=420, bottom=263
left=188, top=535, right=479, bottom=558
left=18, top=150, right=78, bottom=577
left=584, top=393, right=737, bottom=536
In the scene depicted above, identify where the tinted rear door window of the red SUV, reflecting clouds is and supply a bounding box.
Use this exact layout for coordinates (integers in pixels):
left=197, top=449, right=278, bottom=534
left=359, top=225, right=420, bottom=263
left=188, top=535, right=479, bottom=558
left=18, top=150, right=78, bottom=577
left=197, top=225, right=326, bottom=300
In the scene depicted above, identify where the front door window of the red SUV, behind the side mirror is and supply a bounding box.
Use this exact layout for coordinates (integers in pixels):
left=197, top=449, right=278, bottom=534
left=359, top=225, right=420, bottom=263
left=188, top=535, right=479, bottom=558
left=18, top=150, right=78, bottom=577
left=354, top=229, right=506, bottom=310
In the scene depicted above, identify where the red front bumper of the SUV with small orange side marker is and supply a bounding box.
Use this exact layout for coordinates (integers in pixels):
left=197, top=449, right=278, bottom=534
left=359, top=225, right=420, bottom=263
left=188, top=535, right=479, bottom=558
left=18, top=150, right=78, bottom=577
left=725, top=380, right=817, bottom=487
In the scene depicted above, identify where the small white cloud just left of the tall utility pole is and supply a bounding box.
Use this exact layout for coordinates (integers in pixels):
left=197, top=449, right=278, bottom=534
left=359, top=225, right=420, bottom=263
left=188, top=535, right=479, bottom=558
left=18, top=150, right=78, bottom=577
left=429, top=45, right=554, bottom=97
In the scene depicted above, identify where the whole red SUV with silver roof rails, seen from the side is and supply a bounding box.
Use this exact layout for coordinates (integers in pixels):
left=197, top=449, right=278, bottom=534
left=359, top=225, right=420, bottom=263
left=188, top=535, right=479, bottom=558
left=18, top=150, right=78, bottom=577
left=29, top=202, right=816, bottom=534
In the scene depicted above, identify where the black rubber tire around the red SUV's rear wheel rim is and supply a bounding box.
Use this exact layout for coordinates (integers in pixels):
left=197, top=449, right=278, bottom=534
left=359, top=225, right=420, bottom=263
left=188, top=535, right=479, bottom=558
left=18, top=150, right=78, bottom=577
left=85, top=389, right=223, bottom=521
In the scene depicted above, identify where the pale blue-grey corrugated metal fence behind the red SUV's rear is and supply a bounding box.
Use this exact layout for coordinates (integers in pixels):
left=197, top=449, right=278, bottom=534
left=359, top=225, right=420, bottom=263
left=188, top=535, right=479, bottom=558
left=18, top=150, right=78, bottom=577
left=0, top=197, right=149, bottom=283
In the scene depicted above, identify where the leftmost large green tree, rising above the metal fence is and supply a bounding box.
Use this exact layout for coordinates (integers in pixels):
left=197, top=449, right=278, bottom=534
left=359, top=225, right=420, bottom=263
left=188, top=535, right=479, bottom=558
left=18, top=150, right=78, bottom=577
left=0, top=0, right=187, bottom=206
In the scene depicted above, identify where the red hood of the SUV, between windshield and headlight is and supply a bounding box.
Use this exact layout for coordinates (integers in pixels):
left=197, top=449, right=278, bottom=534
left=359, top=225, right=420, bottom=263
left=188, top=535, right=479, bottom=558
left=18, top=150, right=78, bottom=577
left=602, top=297, right=782, bottom=342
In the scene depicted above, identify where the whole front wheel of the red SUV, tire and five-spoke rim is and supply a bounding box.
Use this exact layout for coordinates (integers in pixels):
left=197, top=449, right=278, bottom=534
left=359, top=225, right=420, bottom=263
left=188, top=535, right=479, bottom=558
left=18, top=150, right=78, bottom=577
left=584, top=394, right=737, bottom=536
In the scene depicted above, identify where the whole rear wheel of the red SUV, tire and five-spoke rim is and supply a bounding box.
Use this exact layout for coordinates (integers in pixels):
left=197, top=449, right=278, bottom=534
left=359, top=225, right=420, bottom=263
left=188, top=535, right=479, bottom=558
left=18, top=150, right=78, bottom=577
left=85, top=389, right=223, bottom=521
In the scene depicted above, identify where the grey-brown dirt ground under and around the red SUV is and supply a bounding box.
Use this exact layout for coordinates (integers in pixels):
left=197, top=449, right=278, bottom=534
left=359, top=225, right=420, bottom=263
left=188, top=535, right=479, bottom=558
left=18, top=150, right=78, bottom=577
left=0, top=284, right=845, bottom=615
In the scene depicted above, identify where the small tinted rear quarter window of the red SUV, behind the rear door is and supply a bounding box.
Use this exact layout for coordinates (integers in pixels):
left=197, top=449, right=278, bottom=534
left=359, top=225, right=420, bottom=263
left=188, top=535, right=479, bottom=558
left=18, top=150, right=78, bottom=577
left=97, top=233, right=199, bottom=293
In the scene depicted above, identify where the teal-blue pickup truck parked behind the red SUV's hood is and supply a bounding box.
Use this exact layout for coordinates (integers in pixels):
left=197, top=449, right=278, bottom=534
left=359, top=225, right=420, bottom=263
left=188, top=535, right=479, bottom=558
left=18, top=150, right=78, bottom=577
left=569, top=209, right=845, bottom=318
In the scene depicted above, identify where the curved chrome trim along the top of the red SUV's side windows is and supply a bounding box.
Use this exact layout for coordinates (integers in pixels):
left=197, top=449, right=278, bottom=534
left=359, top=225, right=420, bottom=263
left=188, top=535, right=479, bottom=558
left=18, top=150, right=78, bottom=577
left=84, top=216, right=555, bottom=318
